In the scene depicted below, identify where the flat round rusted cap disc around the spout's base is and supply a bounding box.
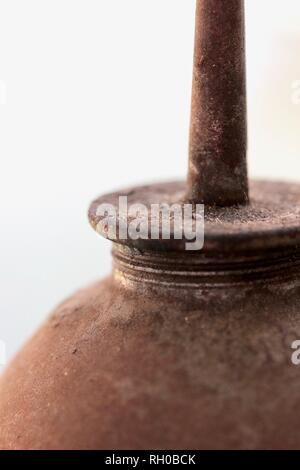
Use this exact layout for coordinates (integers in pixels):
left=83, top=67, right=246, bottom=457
left=89, top=181, right=300, bottom=254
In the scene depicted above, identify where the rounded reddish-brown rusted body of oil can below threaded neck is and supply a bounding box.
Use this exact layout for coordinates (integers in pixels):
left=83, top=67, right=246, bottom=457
left=0, top=266, right=300, bottom=450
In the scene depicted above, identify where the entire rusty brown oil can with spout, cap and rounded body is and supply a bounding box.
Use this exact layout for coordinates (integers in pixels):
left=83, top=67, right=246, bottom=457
left=0, top=0, right=300, bottom=449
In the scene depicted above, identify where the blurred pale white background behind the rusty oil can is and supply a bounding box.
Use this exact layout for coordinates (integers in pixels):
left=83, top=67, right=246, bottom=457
left=0, top=0, right=300, bottom=359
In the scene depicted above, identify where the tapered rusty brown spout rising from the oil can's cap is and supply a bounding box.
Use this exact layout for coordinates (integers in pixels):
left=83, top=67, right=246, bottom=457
left=188, top=0, right=248, bottom=206
